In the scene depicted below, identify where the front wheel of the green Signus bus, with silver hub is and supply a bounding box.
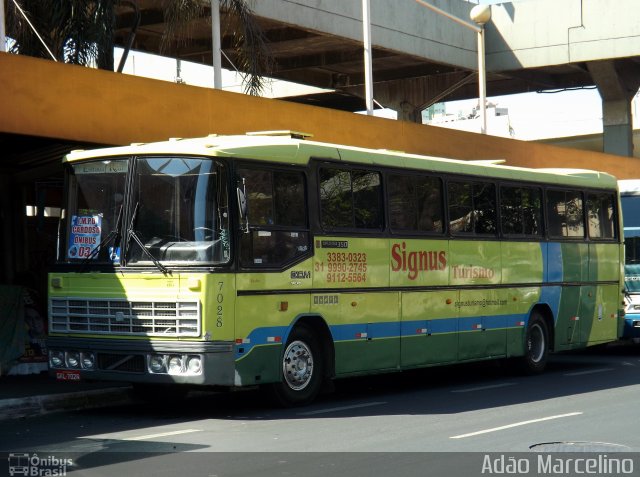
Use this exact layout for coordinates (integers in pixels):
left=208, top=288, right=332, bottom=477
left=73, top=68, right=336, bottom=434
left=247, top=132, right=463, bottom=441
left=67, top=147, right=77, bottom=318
left=268, top=325, right=324, bottom=407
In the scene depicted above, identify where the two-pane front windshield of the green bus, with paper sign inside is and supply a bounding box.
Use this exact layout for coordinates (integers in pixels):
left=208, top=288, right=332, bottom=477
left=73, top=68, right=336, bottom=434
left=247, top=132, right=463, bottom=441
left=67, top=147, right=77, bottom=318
left=65, top=157, right=230, bottom=268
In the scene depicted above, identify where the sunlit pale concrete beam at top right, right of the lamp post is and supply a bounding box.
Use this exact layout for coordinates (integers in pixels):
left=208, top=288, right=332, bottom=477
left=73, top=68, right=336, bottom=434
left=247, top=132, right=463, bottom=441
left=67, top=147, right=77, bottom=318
left=486, top=0, right=640, bottom=71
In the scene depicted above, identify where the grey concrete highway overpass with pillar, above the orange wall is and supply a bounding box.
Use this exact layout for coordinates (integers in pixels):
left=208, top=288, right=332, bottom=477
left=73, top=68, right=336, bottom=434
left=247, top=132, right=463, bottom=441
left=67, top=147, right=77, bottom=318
left=111, top=0, right=640, bottom=156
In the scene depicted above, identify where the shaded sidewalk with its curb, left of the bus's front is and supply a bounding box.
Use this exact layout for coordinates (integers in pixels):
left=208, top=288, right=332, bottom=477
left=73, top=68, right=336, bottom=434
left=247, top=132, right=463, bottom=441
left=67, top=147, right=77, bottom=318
left=0, top=372, right=131, bottom=421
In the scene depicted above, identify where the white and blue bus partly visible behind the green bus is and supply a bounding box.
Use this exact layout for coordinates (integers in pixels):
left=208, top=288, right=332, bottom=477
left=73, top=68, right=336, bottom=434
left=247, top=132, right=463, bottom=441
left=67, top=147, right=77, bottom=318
left=618, top=179, right=640, bottom=342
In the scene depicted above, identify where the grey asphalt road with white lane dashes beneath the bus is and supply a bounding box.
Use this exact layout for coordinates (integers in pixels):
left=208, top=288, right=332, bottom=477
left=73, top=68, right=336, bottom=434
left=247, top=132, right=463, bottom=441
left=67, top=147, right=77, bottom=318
left=0, top=346, right=640, bottom=477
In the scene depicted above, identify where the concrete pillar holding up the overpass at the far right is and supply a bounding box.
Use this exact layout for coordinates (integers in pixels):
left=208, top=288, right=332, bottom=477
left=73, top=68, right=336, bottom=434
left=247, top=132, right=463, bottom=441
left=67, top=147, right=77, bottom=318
left=587, top=60, right=640, bottom=157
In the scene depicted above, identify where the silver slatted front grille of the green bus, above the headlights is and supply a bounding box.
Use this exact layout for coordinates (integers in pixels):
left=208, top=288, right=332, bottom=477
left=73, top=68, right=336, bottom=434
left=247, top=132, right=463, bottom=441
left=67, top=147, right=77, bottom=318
left=49, top=298, right=201, bottom=337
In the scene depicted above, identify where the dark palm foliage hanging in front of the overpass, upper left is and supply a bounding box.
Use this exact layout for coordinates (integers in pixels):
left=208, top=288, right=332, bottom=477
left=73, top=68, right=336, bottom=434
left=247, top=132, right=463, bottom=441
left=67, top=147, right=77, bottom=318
left=5, top=0, right=271, bottom=95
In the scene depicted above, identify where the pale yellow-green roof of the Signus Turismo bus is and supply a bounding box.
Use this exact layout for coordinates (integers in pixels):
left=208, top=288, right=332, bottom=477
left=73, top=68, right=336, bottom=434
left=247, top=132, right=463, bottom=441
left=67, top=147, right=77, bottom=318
left=64, top=131, right=620, bottom=189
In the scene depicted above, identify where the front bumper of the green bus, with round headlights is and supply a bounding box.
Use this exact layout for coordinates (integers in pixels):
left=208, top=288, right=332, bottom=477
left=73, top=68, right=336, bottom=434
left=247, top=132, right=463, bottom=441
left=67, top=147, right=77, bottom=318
left=47, top=337, right=235, bottom=386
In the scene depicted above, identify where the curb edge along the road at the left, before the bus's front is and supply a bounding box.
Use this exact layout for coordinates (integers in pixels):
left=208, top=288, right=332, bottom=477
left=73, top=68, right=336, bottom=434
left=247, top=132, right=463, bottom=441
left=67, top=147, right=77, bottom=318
left=0, top=387, right=133, bottom=421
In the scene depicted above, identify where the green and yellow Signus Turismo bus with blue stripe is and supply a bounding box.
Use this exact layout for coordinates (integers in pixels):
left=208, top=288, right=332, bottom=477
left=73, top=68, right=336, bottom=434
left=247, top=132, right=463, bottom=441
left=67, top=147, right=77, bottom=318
left=48, top=131, right=623, bottom=405
